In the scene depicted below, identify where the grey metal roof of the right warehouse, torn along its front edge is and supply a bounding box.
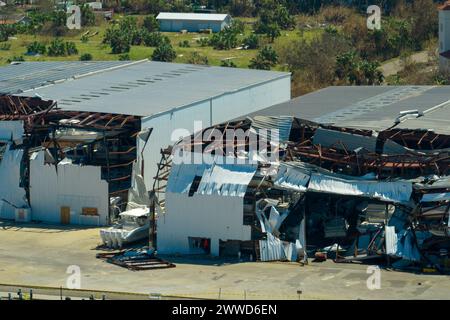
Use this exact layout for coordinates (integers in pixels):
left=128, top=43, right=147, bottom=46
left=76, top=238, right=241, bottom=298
left=244, top=86, right=450, bottom=134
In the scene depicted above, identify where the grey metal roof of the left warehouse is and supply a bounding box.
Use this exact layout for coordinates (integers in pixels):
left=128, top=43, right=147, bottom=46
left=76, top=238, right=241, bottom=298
left=0, top=60, right=290, bottom=117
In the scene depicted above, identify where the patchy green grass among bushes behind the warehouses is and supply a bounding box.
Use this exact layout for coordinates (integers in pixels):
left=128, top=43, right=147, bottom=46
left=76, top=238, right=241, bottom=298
left=0, top=17, right=320, bottom=69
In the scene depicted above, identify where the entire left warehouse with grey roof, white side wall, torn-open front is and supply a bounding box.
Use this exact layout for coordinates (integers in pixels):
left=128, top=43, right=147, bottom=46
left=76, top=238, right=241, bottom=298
left=0, top=60, right=290, bottom=226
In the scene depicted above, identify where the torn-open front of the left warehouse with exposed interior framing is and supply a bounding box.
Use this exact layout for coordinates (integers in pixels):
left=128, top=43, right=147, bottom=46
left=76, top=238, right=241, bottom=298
left=0, top=94, right=140, bottom=225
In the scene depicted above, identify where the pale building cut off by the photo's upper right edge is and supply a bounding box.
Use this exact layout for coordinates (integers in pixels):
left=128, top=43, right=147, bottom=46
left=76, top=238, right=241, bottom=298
left=439, top=1, right=450, bottom=71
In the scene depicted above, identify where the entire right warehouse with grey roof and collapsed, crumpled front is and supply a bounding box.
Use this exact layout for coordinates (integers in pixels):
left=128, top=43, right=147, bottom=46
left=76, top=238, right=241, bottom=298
left=152, top=86, right=450, bottom=272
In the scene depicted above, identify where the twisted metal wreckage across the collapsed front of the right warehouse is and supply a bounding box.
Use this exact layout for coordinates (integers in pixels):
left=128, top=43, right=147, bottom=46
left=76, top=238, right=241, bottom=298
left=154, top=116, right=450, bottom=272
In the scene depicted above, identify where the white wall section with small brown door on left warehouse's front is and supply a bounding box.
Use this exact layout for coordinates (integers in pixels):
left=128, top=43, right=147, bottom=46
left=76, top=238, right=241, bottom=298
left=30, top=151, right=109, bottom=226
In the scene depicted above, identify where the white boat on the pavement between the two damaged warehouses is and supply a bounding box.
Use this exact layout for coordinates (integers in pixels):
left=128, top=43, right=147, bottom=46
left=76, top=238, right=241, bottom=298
left=100, top=208, right=150, bottom=248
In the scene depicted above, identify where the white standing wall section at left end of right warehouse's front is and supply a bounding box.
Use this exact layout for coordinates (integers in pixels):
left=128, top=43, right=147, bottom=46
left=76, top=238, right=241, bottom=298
left=157, top=155, right=256, bottom=256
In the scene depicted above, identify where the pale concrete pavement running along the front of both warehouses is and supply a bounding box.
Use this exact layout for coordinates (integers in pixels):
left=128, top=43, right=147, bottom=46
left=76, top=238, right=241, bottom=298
left=0, top=222, right=450, bottom=300
